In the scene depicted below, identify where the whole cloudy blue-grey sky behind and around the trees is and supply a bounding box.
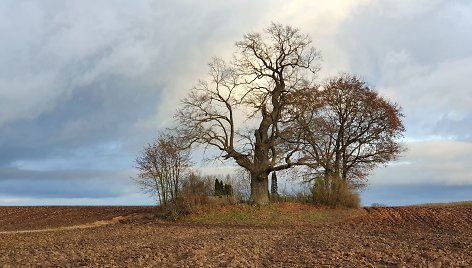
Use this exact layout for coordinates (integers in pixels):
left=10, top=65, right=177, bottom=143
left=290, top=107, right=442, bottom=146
left=0, top=0, right=472, bottom=205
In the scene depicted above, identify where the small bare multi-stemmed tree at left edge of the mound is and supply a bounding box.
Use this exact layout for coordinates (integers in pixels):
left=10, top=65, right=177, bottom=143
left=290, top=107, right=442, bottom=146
left=135, top=134, right=190, bottom=206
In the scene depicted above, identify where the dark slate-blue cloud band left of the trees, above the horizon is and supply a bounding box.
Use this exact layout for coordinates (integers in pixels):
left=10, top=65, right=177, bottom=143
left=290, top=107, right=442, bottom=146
left=0, top=77, right=159, bottom=166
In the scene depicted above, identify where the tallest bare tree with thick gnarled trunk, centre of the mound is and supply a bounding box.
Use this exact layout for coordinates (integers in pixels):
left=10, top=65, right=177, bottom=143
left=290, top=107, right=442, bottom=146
left=176, top=24, right=319, bottom=204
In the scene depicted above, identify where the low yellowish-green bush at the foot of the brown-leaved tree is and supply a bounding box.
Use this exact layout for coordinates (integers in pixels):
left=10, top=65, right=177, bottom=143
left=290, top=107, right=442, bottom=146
left=312, top=177, right=360, bottom=208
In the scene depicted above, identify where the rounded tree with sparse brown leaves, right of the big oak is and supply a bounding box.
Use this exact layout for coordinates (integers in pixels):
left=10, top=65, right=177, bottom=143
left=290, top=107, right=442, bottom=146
left=292, top=75, right=405, bottom=188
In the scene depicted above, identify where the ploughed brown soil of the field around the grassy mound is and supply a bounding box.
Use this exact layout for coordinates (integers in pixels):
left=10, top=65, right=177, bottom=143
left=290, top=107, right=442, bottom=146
left=0, top=207, right=472, bottom=267
